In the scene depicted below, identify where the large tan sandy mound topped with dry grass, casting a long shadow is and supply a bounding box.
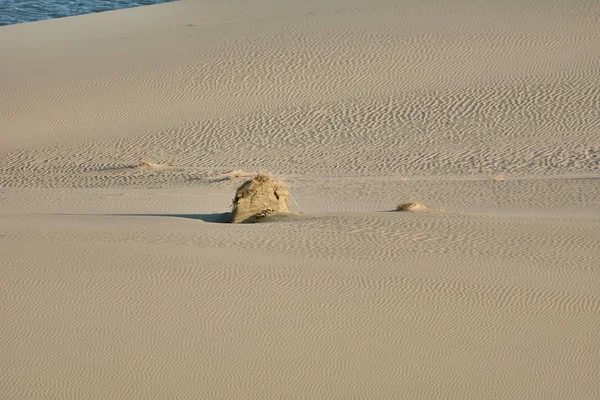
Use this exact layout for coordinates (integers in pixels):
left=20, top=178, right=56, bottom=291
left=228, top=173, right=290, bottom=224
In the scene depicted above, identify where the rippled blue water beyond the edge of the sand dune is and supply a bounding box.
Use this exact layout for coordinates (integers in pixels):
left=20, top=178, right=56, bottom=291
left=0, top=0, right=174, bottom=26
